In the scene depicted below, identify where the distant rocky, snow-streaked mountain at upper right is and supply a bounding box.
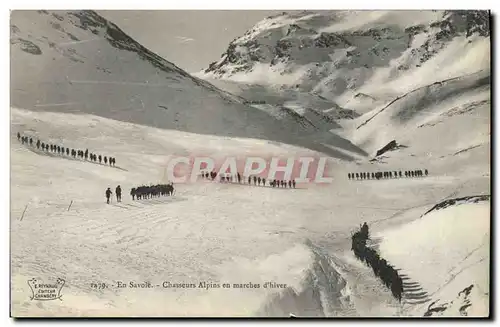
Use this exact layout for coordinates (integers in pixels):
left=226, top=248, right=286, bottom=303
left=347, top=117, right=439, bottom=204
left=199, top=11, right=490, bottom=98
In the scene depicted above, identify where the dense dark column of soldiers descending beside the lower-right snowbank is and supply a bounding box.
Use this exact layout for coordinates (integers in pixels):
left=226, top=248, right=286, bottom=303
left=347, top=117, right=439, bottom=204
left=351, top=223, right=403, bottom=302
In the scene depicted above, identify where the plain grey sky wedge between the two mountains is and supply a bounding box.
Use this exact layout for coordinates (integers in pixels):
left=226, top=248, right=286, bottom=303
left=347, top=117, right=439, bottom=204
left=97, top=10, right=283, bottom=73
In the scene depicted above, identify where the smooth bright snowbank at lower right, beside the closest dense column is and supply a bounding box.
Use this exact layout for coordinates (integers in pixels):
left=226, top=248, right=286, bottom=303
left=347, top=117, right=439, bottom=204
left=378, top=196, right=491, bottom=317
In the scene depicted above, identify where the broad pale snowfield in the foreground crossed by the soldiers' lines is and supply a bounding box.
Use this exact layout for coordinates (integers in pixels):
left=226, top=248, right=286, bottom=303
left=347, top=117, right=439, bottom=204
left=11, top=108, right=490, bottom=316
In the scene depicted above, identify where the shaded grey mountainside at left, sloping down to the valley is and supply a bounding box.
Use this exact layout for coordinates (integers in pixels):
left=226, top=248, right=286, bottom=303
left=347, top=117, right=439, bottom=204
left=11, top=10, right=363, bottom=160
